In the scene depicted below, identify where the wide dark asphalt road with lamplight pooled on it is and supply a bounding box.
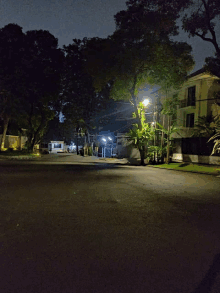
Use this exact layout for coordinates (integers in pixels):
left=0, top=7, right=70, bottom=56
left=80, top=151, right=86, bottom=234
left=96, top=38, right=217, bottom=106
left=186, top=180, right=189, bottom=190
left=0, top=160, right=220, bottom=293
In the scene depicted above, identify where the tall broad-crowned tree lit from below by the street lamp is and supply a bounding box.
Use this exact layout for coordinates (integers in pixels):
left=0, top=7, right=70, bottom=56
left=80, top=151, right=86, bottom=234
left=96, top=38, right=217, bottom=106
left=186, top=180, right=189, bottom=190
left=84, top=1, right=194, bottom=162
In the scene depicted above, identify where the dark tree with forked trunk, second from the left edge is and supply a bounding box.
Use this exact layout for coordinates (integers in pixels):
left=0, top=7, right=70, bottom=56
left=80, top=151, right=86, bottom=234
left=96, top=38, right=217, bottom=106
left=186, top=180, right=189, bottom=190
left=21, top=30, right=63, bottom=152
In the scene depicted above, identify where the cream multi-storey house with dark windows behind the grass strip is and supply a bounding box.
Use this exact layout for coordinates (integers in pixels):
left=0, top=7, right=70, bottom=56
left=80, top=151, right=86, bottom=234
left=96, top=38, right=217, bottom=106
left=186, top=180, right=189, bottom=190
left=164, top=69, right=220, bottom=164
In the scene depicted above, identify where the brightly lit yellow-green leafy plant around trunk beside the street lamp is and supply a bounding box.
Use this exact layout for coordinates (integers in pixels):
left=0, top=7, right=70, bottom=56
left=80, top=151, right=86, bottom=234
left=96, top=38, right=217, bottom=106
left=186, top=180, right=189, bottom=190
left=128, top=102, right=154, bottom=166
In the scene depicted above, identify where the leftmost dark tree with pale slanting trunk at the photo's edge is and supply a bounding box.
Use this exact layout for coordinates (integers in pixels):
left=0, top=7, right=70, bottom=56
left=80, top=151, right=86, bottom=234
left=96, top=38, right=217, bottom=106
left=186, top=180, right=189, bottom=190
left=0, top=24, right=24, bottom=150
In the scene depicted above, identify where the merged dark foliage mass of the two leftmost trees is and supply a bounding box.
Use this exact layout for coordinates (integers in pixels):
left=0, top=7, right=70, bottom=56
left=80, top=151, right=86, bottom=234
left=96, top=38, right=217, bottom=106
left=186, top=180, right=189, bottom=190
left=0, top=24, right=63, bottom=150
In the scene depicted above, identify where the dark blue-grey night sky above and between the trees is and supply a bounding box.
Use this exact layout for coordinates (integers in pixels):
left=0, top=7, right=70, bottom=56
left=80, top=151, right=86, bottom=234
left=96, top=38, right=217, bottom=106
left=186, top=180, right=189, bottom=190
left=0, top=0, right=220, bottom=71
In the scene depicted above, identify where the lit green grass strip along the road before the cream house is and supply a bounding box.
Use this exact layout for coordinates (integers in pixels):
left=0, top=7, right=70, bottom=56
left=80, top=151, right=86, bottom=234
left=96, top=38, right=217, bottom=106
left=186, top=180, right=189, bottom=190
left=150, top=163, right=220, bottom=175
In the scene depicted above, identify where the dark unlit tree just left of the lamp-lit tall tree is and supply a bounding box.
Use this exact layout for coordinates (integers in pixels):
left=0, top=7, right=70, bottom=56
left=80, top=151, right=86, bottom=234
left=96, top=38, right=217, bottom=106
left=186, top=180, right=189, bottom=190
left=62, top=38, right=109, bottom=154
